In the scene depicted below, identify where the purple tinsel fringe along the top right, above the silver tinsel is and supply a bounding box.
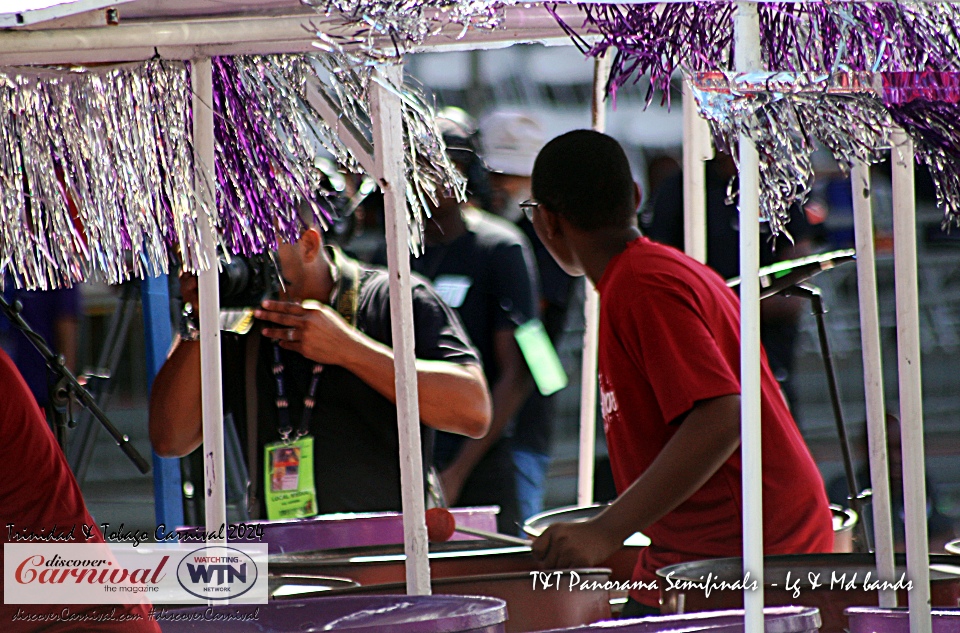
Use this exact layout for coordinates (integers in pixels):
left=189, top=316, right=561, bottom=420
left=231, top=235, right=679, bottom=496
left=547, top=1, right=960, bottom=103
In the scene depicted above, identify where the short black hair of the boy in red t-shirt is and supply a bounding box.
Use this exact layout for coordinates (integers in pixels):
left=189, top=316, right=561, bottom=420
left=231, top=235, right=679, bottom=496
left=532, top=130, right=636, bottom=231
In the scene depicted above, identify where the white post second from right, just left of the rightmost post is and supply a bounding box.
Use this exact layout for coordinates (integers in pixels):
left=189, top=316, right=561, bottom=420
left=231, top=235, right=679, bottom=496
left=850, top=161, right=897, bottom=607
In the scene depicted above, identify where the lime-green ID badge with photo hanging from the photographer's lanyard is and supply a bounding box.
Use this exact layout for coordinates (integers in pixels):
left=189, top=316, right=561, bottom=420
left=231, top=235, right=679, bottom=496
left=263, top=435, right=317, bottom=521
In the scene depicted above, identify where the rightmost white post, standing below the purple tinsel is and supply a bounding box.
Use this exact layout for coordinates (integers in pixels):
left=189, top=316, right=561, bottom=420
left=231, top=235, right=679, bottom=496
left=890, top=130, right=931, bottom=633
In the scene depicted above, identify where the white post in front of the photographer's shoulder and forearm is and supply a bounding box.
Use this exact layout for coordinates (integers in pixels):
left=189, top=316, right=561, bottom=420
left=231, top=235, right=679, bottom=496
left=370, top=64, right=430, bottom=596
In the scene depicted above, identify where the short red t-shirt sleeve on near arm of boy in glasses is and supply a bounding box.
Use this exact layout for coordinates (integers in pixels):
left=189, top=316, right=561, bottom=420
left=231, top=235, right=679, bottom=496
left=624, top=275, right=740, bottom=423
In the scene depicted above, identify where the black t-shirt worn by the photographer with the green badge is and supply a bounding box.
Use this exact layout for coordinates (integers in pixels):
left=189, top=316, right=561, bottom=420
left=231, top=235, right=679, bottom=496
left=223, top=266, right=479, bottom=514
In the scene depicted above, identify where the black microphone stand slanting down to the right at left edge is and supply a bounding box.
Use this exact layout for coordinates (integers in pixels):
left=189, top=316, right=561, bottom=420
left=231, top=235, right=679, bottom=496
left=0, top=297, right=150, bottom=474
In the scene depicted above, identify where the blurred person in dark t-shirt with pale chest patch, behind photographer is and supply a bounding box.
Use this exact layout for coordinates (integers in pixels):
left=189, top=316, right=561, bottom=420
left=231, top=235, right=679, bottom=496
left=411, top=111, right=538, bottom=534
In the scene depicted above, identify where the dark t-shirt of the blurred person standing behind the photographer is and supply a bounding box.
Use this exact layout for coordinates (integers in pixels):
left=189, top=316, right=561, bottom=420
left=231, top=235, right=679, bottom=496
left=411, top=209, right=537, bottom=468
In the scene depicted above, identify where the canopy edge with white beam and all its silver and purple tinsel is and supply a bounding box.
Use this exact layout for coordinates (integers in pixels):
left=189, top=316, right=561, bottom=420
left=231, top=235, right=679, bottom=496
left=0, top=0, right=960, bottom=288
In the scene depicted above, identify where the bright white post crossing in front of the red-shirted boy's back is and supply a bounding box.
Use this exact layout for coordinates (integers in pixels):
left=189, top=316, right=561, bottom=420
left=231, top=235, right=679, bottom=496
left=734, top=0, right=764, bottom=633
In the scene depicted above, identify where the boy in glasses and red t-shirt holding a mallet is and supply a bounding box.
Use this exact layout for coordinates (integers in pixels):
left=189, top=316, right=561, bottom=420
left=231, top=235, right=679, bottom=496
left=527, top=130, right=833, bottom=615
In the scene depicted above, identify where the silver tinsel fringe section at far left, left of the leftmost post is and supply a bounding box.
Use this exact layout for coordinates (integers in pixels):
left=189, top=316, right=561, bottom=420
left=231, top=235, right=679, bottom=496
left=0, top=61, right=210, bottom=289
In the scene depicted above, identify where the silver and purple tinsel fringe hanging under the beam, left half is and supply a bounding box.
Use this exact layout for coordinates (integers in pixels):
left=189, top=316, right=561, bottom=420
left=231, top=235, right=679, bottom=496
left=0, top=51, right=465, bottom=289
